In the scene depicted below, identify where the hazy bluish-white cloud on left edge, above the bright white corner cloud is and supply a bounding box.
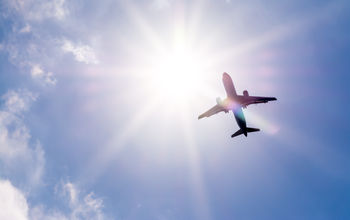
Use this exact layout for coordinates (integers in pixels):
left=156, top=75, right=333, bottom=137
left=0, top=90, right=45, bottom=186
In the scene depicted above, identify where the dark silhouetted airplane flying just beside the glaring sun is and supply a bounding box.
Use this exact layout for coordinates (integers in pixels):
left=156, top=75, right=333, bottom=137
left=198, top=72, right=277, bottom=138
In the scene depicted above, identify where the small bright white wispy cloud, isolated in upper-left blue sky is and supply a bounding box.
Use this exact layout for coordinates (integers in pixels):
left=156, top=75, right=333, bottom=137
left=61, top=40, right=99, bottom=64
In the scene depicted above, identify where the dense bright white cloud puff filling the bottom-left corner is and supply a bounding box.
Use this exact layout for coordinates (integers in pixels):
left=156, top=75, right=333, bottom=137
left=0, top=180, right=28, bottom=220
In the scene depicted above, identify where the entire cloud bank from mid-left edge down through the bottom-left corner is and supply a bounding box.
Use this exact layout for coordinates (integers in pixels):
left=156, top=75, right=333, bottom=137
left=0, top=90, right=106, bottom=220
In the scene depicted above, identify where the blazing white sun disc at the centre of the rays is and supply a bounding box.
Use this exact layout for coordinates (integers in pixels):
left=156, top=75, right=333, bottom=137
left=144, top=34, right=206, bottom=104
